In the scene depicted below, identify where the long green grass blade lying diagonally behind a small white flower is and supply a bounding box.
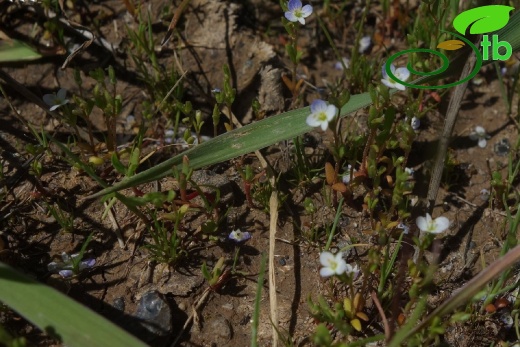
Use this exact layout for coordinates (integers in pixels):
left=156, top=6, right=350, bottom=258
left=90, top=89, right=372, bottom=198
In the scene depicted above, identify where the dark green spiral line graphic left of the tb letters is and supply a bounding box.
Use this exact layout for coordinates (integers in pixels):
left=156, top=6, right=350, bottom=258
left=385, top=30, right=483, bottom=89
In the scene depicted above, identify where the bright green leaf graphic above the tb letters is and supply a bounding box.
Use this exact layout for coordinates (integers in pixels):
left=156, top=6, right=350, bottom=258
left=453, top=5, right=515, bottom=35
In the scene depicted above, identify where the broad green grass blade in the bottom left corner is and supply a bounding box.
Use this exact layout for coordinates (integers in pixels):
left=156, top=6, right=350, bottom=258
left=0, top=262, right=146, bottom=347
